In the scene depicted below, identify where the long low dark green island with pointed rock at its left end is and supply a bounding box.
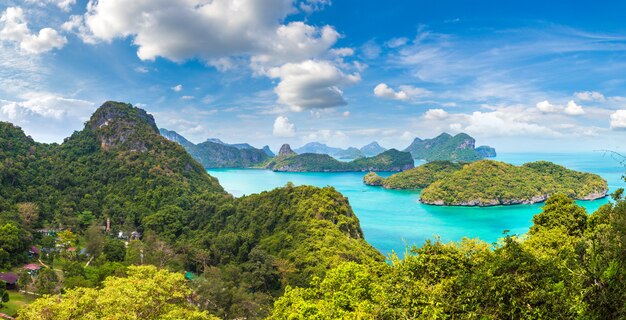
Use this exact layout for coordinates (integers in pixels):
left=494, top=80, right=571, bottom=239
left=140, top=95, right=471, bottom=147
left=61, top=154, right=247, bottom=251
left=262, top=144, right=414, bottom=172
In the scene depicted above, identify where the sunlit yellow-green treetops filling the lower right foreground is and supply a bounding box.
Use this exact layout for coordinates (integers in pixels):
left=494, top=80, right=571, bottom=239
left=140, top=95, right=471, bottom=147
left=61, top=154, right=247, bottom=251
left=270, top=191, right=626, bottom=319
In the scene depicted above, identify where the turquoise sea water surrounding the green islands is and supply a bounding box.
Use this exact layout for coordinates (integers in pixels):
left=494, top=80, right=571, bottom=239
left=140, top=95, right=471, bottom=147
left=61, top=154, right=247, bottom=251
left=208, top=152, right=626, bottom=254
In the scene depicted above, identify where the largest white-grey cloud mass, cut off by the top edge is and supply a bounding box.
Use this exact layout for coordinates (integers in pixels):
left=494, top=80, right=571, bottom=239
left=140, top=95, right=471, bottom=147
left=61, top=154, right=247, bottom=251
left=74, top=0, right=339, bottom=67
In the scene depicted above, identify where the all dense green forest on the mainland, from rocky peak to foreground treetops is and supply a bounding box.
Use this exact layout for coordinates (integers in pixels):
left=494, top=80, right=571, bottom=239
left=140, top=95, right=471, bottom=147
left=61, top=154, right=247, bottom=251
left=0, top=102, right=626, bottom=319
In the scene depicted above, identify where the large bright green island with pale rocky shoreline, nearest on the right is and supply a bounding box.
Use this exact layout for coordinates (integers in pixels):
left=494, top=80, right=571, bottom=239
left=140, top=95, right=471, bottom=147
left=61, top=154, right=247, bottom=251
left=420, top=160, right=608, bottom=206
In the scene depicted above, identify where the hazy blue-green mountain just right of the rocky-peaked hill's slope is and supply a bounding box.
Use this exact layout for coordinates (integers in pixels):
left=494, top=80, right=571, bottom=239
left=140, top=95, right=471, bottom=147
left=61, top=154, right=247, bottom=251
left=159, top=129, right=274, bottom=168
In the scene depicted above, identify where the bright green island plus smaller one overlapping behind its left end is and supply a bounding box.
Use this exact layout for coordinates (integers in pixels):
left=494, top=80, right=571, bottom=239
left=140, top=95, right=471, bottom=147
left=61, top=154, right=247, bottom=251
left=363, top=160, right=608, bottom=207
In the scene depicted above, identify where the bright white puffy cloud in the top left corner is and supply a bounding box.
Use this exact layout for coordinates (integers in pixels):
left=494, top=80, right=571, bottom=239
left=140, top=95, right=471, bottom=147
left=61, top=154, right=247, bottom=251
left=0, top=7, right=67, bottom=54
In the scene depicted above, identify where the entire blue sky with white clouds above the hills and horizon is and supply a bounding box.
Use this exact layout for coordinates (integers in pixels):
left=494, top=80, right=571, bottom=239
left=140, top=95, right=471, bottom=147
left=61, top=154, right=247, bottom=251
left=0, top=0, right=626, bottom=151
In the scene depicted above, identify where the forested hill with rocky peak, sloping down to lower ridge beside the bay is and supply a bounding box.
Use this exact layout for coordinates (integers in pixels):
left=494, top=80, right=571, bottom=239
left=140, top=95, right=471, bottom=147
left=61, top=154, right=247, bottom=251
left=0, top=102, right=383, bottom=318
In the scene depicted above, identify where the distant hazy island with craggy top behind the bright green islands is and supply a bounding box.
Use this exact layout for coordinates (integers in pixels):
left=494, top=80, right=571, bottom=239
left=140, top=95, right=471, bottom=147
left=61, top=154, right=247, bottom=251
left=404, top=132, right=496, bottom=162
